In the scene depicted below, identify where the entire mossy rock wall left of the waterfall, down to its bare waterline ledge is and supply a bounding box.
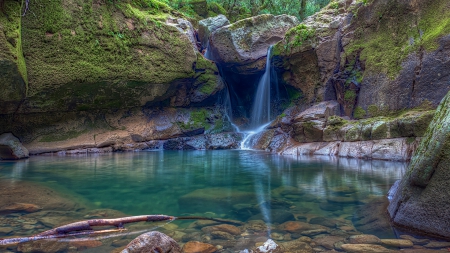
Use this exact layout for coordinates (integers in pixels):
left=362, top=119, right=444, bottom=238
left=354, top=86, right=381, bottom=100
left=0, top=0, right=230, bottom=154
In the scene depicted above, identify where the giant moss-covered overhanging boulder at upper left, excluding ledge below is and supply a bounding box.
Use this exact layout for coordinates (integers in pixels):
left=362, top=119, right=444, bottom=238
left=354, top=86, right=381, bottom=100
left=6, top=0, right=218, bottom=113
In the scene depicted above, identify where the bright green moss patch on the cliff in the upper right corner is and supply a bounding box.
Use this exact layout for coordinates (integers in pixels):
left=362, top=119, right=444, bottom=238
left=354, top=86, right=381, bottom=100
left=345, top=0, right=450, bottom=79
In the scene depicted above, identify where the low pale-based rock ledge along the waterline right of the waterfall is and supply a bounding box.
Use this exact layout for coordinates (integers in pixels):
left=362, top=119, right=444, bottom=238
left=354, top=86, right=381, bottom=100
left=248, top=101, right=434, bottom=161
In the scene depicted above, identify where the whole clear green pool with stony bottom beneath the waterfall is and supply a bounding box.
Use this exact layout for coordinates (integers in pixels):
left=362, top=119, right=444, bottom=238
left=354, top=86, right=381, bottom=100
left=0, top=150, right=450, bottom=252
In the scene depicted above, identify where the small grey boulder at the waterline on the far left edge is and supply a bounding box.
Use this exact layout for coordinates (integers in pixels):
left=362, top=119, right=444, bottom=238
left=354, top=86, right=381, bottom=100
left=0, top=133, right=29, bottom=160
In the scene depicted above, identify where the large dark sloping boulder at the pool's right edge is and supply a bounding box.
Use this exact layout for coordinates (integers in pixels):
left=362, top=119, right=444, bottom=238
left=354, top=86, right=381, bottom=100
left=388, top=92, right=450, bottom=238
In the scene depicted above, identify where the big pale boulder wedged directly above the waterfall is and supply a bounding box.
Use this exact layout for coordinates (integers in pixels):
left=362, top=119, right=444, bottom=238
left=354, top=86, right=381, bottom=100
left=210, top=14, right=298, bottom=74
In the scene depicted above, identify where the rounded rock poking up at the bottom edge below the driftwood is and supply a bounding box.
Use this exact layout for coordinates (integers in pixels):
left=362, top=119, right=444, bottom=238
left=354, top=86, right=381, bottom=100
left=121, top=231, right=181, bottom=253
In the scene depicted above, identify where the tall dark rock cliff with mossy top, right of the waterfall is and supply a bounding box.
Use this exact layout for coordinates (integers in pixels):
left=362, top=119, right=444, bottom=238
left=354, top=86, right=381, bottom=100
left=274, top=0, right=450, bottom=117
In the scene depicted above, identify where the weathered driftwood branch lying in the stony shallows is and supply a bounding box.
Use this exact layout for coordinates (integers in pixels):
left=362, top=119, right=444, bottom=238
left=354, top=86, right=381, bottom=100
left=0, top=215, right=243, bottom=245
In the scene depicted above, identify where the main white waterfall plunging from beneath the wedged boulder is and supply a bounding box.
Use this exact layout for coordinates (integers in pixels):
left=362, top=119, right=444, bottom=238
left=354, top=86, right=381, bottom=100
left=250, top=46, right=273, bottom=129
